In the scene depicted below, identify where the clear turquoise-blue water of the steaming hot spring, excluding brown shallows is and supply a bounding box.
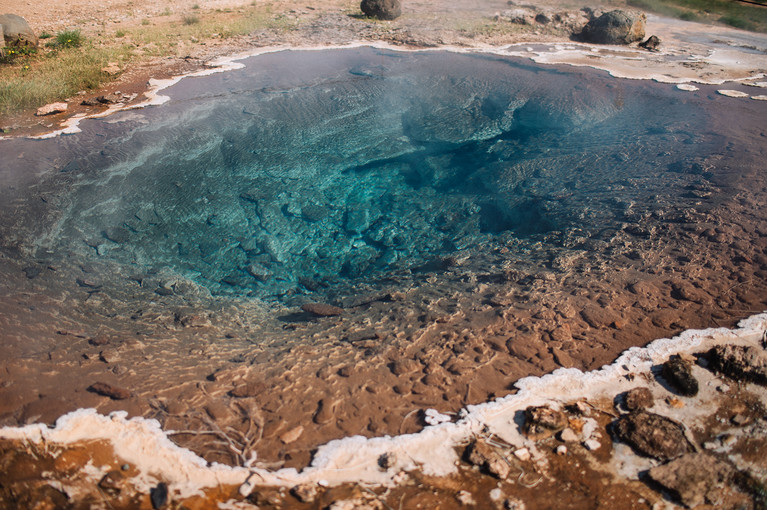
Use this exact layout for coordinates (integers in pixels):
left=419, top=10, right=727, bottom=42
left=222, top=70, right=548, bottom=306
left=0, top=48, right=721, bottom=300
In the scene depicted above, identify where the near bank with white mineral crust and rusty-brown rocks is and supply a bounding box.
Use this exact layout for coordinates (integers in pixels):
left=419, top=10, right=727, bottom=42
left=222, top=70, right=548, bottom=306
left=0, top=315, right=767, bottom=509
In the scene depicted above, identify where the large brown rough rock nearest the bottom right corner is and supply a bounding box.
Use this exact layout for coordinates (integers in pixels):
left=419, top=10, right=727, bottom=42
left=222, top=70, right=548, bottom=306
left=648, top=453, right=735, bottom=508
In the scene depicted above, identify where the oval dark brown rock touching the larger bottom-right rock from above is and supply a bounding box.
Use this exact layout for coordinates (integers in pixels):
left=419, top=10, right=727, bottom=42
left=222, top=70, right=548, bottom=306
left=614, top=411, right=692, bottom=460
